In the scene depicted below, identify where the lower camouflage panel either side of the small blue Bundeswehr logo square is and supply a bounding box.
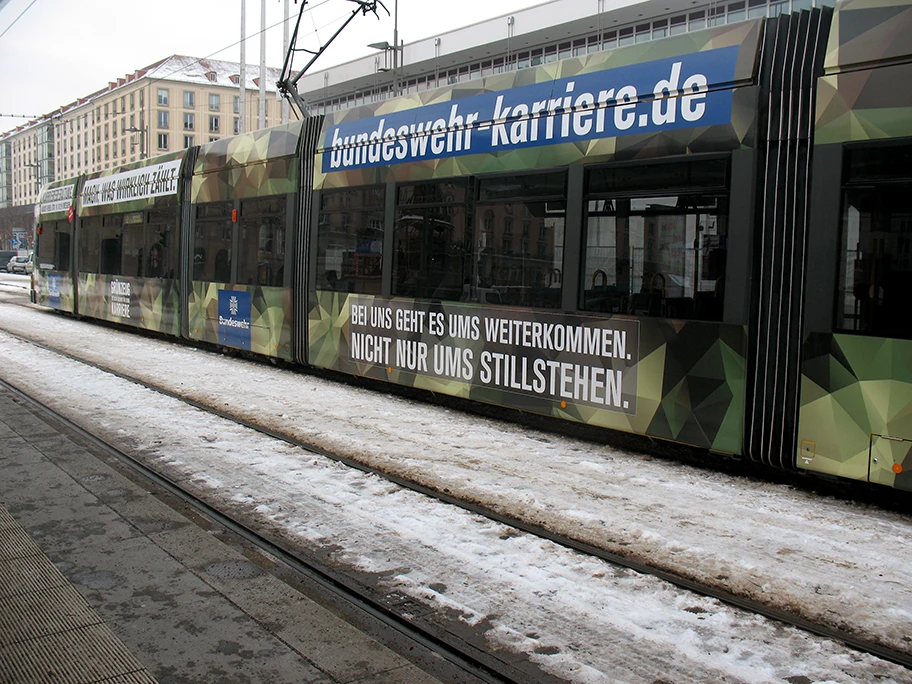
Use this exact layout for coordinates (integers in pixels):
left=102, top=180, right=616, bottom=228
left=187, top=280, right=292, bottom=361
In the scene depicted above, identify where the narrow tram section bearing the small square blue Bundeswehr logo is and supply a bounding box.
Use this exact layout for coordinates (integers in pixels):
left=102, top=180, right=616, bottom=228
left=187, top=122, right=302, bottom=361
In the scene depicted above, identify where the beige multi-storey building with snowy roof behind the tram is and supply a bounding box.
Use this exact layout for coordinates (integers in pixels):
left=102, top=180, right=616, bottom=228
left=0, top=55, right=281, bottom=209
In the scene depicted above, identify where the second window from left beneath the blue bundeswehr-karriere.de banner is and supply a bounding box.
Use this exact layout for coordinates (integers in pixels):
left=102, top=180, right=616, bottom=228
left=393, top=179, right=468, bottom=300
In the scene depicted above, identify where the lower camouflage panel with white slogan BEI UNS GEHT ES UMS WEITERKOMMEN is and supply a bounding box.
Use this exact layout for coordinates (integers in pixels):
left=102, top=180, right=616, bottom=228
left=309, top=291, right=747, bottom=453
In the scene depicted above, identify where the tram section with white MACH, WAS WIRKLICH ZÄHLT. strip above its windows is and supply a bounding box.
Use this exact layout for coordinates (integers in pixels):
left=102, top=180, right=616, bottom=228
left=76, top=150, right=187, bottom=336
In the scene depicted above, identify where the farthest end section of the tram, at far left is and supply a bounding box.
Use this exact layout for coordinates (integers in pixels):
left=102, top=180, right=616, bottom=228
left=32, top=178, right=79, bottom=313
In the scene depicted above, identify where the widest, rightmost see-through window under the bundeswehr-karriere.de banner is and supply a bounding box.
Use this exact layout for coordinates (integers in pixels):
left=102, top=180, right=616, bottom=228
left=580, top=160, right=728, bottom=321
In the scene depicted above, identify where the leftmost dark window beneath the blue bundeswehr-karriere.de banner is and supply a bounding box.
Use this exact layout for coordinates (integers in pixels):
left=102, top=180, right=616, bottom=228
left=317, top=185, right=386, bottom=294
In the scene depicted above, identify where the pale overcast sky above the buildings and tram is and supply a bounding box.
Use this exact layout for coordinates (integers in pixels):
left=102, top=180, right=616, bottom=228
left=0, top=0, right=540, bottom=132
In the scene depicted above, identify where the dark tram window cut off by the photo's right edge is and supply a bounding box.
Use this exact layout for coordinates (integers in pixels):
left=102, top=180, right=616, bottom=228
left=836, top=145, right=912, bottom=339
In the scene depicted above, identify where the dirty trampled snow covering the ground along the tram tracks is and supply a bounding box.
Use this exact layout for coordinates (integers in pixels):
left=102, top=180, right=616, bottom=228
left=0, top=276, right=912, bottom=682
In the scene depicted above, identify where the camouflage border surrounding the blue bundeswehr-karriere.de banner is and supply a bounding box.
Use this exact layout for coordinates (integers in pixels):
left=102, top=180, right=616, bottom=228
left=314, top=20, right=763, bottom=188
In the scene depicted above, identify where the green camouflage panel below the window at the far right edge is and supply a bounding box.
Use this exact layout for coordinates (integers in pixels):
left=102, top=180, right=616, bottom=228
left=798, top=334, right=912, bottom=491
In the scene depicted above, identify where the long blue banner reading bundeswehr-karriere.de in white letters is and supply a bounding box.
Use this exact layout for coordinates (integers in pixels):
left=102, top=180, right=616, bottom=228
left=323, top=46, right=739, bottom=173
